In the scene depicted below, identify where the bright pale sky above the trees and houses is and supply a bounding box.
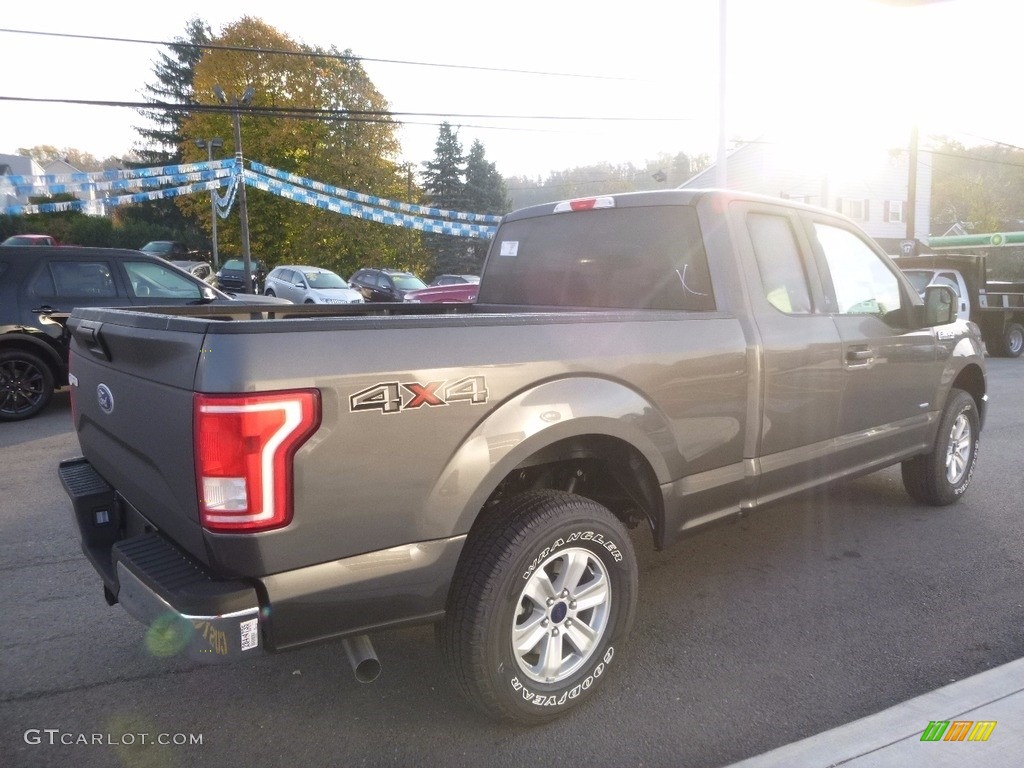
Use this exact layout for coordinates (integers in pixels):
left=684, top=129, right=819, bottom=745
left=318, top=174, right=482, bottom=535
left=0, top=0, right=1024, bottom=178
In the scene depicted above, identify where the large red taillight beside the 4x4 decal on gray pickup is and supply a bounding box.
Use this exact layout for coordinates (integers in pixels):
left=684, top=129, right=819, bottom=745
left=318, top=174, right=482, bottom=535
left=193, top=389, right=321, bottom=534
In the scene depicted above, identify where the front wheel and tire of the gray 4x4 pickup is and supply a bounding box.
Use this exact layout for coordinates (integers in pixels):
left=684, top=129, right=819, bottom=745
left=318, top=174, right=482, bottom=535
left=902, top=389, right=981, bottom=507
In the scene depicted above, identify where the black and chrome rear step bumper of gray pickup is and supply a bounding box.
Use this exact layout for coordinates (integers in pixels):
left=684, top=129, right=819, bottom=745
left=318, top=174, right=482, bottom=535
left=58, top=459, right=265, bottom=664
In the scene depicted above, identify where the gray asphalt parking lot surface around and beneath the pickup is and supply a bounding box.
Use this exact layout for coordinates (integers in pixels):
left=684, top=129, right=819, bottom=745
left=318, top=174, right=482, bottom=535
left=0, top=359, right=1024, bottom=768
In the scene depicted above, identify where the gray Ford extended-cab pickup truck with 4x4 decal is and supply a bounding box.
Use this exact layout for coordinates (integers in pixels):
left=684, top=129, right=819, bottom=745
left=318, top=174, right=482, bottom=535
left=59, top=190, right=986, bottom=723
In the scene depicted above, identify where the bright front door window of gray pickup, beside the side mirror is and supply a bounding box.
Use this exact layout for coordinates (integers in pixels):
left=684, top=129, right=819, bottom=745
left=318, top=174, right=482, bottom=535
left=814, top=222, right=902, bottom=325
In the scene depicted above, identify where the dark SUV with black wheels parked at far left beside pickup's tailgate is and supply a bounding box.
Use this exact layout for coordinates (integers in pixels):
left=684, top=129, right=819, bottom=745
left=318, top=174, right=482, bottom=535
left=0, top=246, right=280, bottom=421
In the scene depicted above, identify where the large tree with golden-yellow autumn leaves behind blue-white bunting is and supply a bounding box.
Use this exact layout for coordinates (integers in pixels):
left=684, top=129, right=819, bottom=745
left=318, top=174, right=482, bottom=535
left=179, top=16, right=423, bottom=275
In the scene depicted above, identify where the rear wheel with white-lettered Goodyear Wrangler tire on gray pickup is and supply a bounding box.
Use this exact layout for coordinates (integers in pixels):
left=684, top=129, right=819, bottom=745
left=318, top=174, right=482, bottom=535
left=438, top=490, right=637, bottom=724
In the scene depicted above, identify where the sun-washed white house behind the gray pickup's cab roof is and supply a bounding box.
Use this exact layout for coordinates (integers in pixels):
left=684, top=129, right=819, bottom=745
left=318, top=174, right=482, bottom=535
left=680, top=140, right=932, bottom=255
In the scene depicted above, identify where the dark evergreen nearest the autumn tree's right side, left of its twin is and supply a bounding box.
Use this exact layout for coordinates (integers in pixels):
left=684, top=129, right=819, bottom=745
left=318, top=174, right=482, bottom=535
left=423, top=122, right=473, bottom=274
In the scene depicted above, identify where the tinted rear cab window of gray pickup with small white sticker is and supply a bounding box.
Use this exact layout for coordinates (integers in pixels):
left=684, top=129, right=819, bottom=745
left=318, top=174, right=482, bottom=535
left=478, top=206, right=715, bottom=310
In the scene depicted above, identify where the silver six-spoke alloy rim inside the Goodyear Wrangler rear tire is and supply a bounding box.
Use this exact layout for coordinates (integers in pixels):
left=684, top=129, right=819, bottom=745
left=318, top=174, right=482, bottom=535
left=512, top=548, right=611, bottom=683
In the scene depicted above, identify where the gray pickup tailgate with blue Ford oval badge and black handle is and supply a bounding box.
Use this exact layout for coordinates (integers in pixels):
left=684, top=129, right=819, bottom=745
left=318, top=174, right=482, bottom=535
left=69, top=310, right=207, bottom=559
